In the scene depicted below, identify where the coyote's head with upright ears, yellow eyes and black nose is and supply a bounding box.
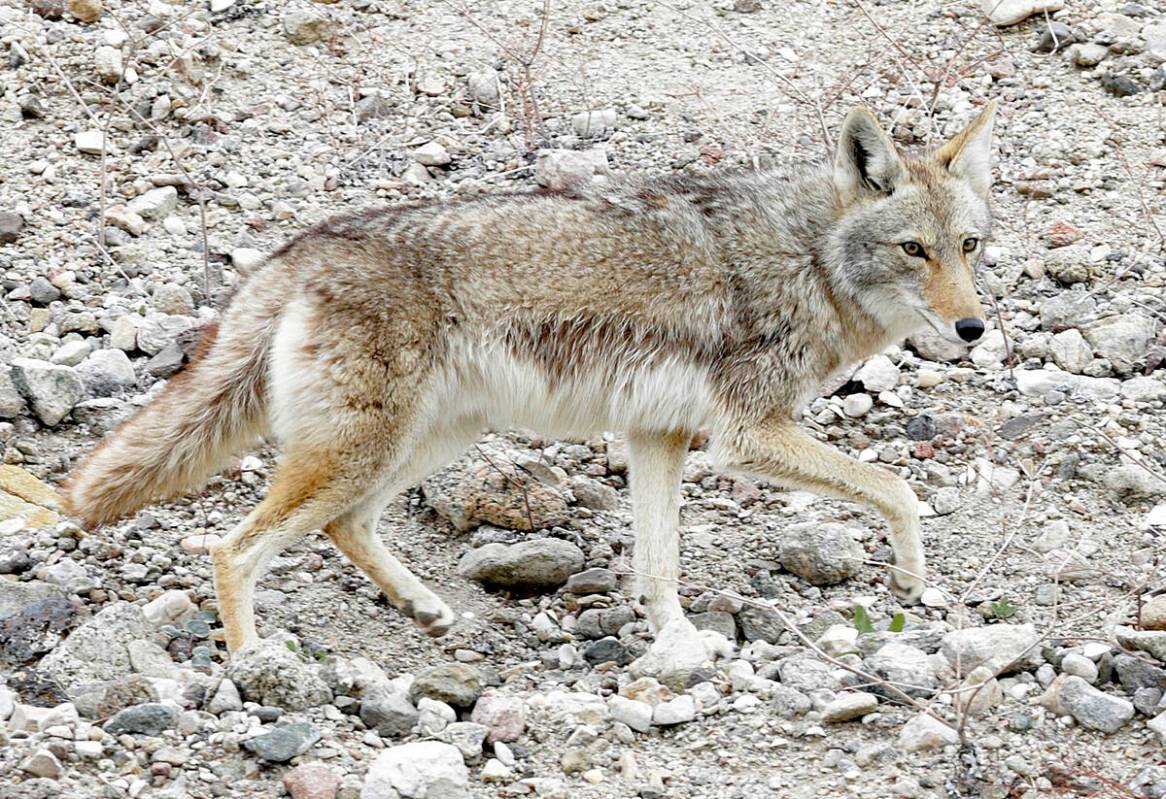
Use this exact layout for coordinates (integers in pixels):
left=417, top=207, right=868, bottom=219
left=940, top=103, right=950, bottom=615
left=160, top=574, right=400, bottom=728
left=830, top=100, right=996, bottom=343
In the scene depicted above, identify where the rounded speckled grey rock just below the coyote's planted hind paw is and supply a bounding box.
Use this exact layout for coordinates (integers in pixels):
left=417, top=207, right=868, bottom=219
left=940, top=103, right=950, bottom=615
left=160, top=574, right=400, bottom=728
left=226, top=636, right=332, bottom=710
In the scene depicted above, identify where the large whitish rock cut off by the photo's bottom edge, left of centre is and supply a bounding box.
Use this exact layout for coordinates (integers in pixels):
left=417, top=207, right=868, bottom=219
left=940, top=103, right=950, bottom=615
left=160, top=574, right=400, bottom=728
left=360, top=741, right=470, bottom=799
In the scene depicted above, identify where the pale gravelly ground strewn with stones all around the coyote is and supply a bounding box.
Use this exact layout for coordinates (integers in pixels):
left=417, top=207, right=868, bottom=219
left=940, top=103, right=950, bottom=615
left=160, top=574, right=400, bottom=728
left=0, top=0, right=1166, bottom=799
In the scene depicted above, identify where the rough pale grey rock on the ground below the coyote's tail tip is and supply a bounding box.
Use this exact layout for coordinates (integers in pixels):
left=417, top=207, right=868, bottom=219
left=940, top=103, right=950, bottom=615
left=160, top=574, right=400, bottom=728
left=37, top=602, right=153, bottom=692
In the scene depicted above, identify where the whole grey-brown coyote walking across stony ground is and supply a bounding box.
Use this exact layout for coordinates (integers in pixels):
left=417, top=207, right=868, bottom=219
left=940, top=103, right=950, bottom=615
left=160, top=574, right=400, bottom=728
left=65, top=103, right=996, bottom=667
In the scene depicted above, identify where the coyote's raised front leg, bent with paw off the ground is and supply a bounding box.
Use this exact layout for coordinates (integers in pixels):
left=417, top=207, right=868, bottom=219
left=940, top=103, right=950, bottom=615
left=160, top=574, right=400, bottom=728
left=721, top=420, right=926, bottom=602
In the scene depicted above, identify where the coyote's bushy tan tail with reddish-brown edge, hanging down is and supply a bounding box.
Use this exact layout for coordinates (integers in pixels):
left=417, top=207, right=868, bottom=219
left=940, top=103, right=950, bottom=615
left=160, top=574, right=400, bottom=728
left=64, top=270, right=282, bottom=526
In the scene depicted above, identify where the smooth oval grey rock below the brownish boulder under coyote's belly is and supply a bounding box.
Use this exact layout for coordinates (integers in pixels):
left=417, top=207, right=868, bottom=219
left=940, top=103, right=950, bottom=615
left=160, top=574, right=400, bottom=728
left=457, top=538, right=585, bottom=589
